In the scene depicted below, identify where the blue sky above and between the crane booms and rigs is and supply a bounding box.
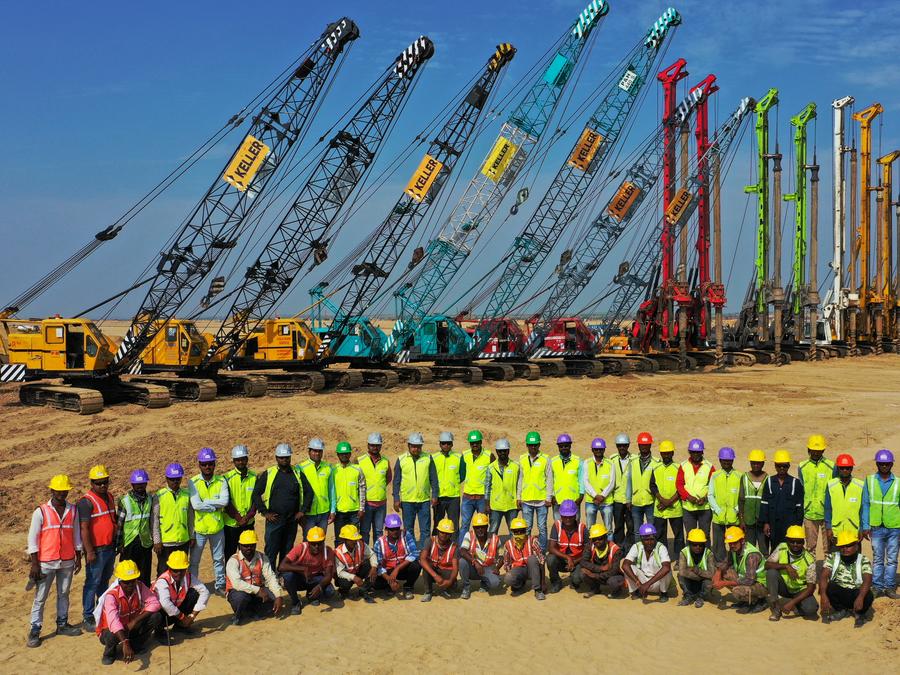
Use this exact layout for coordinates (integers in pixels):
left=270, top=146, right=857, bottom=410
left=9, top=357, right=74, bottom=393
left=0, top=0, right=900, bottom=318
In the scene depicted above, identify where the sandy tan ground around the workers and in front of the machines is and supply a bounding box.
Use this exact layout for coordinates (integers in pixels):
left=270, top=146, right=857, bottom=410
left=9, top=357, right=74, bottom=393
left=0, top=355, right=900, bottom=673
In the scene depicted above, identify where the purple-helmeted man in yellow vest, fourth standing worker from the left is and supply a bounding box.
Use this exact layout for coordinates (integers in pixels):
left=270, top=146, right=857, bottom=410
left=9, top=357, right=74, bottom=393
left=150, top=462, right=196, bottom=574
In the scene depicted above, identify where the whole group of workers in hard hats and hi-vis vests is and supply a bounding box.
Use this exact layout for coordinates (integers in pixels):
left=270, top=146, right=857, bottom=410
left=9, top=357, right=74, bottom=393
left=27, top=430, right=900, bottom=664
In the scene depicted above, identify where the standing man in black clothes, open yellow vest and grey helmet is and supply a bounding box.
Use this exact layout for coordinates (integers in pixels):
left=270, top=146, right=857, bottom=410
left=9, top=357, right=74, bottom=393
left=253, top=443, right=313, bottom=565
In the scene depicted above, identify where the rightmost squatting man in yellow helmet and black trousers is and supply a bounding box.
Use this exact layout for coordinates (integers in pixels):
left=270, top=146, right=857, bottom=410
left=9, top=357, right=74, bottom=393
left=819, top=530, right=875, bottom=628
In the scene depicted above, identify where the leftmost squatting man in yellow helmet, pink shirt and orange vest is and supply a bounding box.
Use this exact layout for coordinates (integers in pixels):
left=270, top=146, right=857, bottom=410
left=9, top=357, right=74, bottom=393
left=94, top=560, right=162, bottom=666
